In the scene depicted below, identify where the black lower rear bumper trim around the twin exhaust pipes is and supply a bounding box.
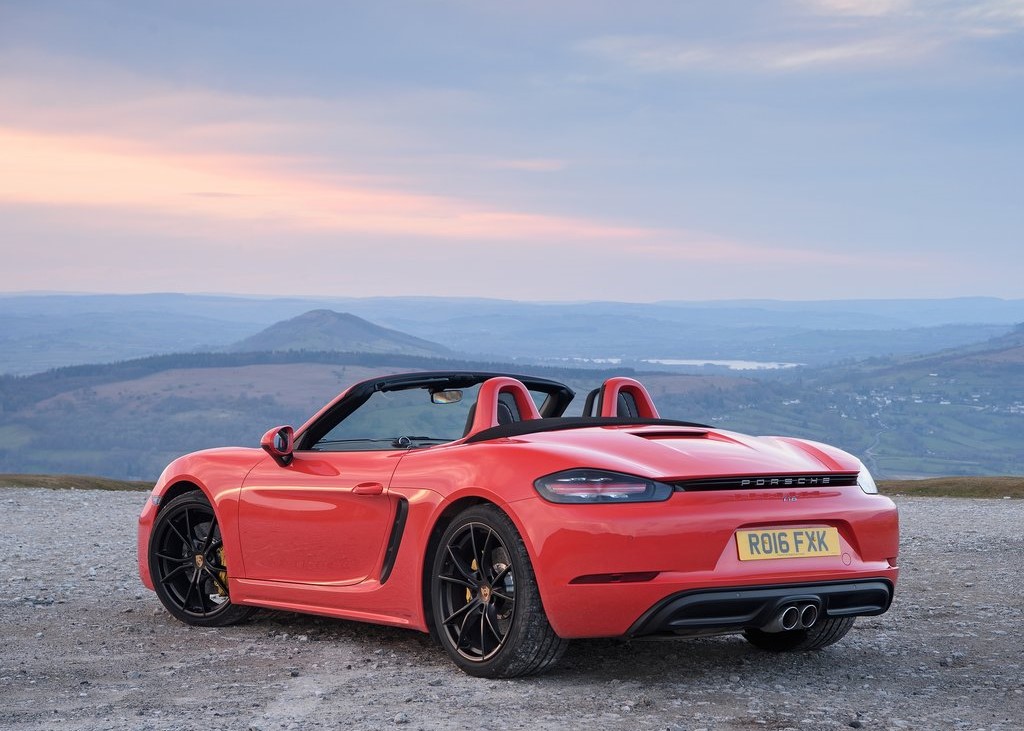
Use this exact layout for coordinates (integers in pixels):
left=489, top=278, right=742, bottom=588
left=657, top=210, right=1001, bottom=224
left=627, top=578, right=893, bottom=637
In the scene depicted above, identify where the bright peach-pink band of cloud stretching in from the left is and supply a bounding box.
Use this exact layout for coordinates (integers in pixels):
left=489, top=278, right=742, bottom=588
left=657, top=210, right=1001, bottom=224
left=0, top=123, right=654, bottom=240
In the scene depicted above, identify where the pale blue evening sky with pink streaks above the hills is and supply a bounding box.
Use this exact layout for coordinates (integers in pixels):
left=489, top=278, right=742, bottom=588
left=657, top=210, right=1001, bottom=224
left=0, top=0, right=1024, bottom=302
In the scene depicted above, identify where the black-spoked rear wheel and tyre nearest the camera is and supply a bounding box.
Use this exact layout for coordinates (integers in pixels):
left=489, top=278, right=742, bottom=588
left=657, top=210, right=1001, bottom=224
left=430, top=505, right=568, bottom=678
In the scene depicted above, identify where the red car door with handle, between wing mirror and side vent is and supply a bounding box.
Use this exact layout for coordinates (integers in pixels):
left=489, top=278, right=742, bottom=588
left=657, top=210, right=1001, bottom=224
left=238, top=450, right=406, bottom=586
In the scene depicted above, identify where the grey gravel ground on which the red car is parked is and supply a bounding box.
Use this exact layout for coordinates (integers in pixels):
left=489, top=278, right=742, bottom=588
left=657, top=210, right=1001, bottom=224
left=0, top=488, right=1024, bottom=731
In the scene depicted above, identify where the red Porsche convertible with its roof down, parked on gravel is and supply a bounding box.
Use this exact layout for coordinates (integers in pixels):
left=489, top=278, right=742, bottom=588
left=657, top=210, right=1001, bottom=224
left=138, top=372, right=899, bottom=677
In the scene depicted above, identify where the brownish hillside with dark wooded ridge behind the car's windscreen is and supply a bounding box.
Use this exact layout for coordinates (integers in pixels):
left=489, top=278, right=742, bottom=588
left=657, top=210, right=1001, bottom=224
left=0, top=351, right=749, bottom=479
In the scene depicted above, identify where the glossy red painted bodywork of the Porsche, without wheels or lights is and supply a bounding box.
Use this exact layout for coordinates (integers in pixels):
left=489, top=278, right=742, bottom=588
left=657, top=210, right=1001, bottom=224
left=138, top=372, right=898, bottom=638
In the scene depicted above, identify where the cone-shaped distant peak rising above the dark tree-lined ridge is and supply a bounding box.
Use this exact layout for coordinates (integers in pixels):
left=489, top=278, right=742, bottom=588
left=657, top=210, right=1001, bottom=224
left=228, top=309, right=452, bottom=356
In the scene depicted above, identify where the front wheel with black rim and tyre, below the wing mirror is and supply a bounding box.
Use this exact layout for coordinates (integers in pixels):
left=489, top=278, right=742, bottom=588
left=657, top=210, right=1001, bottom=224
left=150, top=490, right=254, bottom=627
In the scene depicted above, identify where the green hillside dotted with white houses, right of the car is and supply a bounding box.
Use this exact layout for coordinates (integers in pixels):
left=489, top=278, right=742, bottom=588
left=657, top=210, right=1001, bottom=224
left=688, top=326, right=1024, bottom=478
